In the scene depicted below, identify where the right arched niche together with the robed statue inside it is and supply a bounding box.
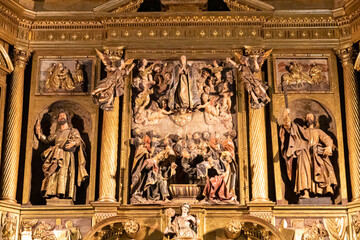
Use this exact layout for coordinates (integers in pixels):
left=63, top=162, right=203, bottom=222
left=279, top=99, right=339, bottom=204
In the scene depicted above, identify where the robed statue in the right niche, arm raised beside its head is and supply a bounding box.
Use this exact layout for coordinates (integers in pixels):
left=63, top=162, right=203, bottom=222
left=279, top=109, right=337, bottom=198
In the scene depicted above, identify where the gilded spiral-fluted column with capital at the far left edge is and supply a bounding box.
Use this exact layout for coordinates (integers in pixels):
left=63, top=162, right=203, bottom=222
left=0, top=48, right=31, bottom=203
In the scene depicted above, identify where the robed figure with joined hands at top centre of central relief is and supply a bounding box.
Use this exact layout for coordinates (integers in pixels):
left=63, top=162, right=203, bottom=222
left=168, top=56, right=200, bottom=110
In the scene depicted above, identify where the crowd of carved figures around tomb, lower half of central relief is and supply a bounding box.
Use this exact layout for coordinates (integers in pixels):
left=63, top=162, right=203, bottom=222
left=131, top=128, right=237, bottom=204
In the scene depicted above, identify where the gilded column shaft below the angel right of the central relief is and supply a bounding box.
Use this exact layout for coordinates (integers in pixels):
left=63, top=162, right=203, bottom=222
left=249, top=108, right=270, bottom=202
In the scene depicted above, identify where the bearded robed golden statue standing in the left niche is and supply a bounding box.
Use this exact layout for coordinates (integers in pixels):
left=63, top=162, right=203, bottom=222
left=36, top=110, right=88, bottom=199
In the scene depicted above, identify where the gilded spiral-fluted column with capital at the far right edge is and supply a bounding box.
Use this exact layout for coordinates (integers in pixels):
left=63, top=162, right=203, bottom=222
left=336, top=47, right=360, bottom=202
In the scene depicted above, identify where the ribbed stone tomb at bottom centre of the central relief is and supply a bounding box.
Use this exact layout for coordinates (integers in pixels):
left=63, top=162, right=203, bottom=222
left=169, top=184, right=201, bottom=203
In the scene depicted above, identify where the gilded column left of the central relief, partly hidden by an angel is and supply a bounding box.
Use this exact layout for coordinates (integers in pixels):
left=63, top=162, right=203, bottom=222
left=98, top=49, right=123, bottom=202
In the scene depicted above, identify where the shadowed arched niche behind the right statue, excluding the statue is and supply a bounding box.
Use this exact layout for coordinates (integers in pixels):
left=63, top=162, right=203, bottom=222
left=277, top=98, right=341, bottom=204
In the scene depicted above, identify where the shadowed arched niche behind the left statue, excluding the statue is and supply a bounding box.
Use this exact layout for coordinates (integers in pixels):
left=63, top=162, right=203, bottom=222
left=30, top=100, right=92, bottom=205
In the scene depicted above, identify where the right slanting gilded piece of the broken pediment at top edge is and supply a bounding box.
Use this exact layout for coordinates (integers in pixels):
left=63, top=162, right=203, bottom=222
left=224, top=0, right=275, bottom=12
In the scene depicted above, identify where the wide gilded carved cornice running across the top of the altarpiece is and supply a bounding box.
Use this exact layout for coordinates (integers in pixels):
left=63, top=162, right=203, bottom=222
left=0, top=0, right=360, bottom=44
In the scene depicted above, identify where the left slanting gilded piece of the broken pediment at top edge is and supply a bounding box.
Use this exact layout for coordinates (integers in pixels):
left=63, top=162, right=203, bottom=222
left=93, top=0, right=144, bottom=13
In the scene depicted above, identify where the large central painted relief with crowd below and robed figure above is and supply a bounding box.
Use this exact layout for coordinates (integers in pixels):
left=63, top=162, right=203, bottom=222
left=130, top=56, right=238, bottom=204
